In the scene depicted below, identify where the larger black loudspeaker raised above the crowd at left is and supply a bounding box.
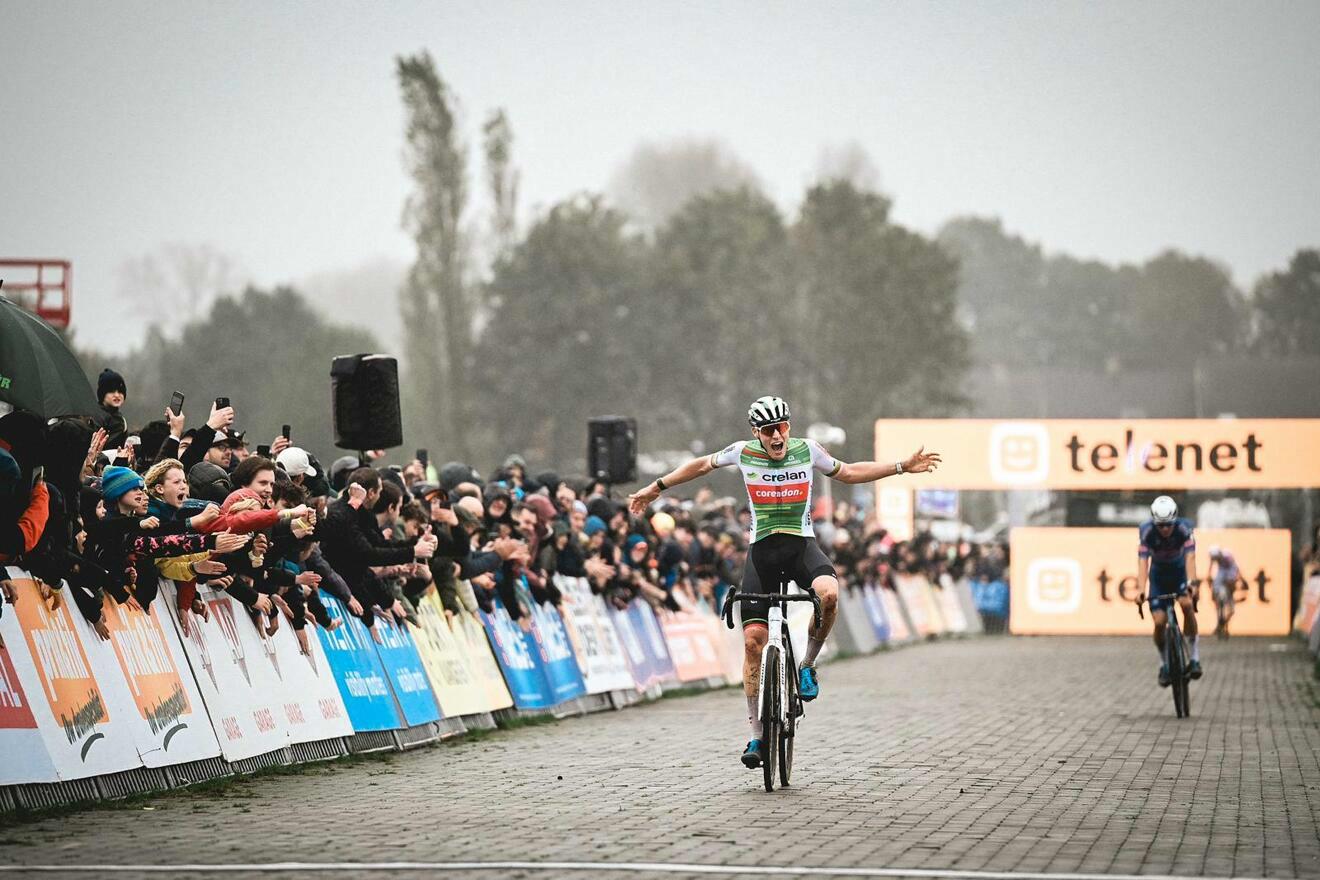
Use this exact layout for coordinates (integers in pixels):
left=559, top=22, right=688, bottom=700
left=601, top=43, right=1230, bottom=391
left=330, top=355, right=404, bottom=450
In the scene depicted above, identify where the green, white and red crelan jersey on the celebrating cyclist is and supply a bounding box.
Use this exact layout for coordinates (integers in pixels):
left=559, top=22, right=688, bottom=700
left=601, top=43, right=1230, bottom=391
left=710, top=437, right=843, bottom=542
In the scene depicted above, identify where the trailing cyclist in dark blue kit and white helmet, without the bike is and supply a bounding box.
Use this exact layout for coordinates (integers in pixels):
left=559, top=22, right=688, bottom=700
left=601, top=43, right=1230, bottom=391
left=1137, top=495, right=1201, bottom=687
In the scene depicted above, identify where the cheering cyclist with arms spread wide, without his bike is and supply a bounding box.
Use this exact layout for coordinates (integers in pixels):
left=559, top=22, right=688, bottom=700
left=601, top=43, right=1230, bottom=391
left=628, top=397, right=940, bottom=768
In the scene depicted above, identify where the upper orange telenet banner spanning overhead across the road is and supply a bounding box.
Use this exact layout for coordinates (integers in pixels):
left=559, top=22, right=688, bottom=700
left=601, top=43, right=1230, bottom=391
left=875, top=418, right=1320, bottom=489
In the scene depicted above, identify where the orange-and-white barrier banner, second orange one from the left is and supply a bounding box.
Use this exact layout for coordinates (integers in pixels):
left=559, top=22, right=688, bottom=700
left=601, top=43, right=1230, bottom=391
left=91, top=596, right=220, bottom=767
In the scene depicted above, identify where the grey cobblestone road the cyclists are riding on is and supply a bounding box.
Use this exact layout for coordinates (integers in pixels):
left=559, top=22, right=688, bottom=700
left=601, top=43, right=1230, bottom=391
left=0, top=639, right=1320, bottom=877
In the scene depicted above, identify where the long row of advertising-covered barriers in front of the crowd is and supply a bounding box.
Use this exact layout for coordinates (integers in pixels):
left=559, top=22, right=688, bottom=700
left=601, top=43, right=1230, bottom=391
left=0, top=567, right=957, bottom=805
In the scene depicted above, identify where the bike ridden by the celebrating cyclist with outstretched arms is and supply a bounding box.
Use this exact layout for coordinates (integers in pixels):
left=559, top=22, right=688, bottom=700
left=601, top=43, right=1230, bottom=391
left=723, top=584, right=821, bottom=792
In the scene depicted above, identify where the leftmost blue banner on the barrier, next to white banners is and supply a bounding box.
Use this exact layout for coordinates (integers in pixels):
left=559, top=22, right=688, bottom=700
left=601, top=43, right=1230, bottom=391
left=317, top=592, right=404, bottom=731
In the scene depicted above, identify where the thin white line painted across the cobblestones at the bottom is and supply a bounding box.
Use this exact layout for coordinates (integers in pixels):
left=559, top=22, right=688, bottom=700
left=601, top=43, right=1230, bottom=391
left=0, top=862, right=1255, bottom=880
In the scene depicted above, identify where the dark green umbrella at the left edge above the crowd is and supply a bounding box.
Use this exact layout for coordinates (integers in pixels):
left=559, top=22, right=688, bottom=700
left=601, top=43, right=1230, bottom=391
left=0, top=296, right=100, bottom=418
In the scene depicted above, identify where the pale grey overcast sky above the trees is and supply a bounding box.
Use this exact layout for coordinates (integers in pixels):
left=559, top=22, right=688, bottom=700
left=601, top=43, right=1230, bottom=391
left=0, top=0, right=1320, bottom=350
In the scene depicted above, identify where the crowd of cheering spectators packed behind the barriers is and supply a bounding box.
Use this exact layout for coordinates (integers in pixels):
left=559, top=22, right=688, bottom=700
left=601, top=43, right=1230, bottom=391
left=0, top=369, right=1007, bottom=650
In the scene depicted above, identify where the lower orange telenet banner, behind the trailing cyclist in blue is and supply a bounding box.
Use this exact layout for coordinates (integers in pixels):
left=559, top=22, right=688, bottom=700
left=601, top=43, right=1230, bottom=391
left=1008, top=526, right=1292, bottom=636
